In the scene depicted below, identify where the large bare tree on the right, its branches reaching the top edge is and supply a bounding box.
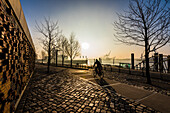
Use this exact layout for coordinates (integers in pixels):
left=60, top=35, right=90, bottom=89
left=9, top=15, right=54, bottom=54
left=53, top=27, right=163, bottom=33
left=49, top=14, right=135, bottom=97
left=114, top=0, right=170, bottom=84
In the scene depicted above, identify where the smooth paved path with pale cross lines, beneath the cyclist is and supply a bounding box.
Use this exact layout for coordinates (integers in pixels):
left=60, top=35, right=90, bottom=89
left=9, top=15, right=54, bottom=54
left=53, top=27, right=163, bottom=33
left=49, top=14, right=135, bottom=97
left=72, top=70, right=170, bottom=113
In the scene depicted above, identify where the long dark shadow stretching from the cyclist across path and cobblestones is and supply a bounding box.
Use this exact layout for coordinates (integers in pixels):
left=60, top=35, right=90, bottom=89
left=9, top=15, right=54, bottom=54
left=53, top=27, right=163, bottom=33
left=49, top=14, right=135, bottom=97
left=95, top=79, right=146, bottom=113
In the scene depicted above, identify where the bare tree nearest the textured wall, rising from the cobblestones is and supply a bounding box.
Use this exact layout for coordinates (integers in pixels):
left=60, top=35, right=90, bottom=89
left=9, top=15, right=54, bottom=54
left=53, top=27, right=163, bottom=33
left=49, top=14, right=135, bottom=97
left=35, top=18, right=61, bottom=73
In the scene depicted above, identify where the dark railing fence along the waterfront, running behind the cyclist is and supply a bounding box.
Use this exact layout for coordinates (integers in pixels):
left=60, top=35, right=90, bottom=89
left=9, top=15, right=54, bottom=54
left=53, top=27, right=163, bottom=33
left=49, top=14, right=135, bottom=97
left=36, top=54, right=170, bottom=81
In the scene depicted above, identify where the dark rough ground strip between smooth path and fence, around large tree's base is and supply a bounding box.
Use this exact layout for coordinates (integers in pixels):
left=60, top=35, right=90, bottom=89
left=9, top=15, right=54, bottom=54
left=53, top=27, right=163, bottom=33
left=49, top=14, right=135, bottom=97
left=105, top=71, right=170, bottom=96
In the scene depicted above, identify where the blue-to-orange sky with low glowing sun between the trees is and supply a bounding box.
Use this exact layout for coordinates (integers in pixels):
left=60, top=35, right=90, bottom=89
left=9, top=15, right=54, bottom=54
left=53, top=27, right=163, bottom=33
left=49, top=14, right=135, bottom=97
left=20, top=0, right=170, bottom=58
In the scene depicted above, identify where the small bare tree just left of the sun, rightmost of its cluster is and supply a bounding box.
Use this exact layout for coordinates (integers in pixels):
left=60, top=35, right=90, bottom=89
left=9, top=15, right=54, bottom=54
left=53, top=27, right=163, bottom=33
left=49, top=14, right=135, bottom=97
left=65, top=33, right=80, bottom=67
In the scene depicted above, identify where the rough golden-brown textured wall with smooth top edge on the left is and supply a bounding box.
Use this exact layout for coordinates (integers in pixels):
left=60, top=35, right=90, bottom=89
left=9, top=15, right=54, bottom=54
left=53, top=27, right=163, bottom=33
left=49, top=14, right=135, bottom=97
left=0, top=0, right=35, bottom=113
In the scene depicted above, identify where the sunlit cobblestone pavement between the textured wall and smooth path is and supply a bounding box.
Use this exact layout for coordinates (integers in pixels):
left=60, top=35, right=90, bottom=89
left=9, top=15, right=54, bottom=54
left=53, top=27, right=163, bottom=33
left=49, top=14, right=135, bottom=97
left=16, top=66, right=156, bottom=113
